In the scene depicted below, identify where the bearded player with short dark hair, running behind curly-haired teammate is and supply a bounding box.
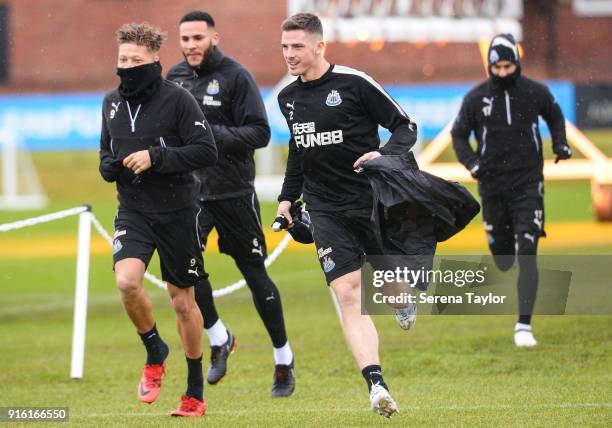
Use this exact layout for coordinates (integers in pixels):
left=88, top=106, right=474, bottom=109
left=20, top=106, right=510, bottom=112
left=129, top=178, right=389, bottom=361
left=168, top=11, right=295, bottom=397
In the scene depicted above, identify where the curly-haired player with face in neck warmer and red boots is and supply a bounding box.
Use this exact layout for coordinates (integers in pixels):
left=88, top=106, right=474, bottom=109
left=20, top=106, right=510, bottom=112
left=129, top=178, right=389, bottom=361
left=100, top=24, right=217, bottom=416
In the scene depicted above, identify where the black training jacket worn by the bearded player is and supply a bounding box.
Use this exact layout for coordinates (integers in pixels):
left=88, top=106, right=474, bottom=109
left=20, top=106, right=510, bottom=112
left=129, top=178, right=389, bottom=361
left=168, top=47, right=270, bottom=201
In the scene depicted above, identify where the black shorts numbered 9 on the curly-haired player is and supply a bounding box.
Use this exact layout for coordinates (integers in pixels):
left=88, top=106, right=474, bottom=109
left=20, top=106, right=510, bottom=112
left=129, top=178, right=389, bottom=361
left=113, top=206, right=206, bottom=288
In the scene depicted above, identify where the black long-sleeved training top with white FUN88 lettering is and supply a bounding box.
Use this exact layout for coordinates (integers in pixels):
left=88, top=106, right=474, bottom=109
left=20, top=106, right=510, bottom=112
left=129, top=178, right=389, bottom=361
left=278, top=65, right=417, bottom=211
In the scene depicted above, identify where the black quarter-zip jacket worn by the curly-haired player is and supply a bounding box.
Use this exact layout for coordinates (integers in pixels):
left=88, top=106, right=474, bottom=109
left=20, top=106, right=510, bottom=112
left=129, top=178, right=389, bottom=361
left=100, top=78, right=217, bottom=212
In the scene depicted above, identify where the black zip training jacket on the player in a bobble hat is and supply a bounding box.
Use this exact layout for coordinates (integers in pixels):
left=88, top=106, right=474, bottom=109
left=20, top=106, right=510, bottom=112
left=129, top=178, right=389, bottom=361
left=451, top=76, right=567, bottom=195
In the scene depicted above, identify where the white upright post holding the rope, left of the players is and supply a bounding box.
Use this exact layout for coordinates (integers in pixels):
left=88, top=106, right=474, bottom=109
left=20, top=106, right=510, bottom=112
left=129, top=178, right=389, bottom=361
left=70, top=206, right=93, bottom=379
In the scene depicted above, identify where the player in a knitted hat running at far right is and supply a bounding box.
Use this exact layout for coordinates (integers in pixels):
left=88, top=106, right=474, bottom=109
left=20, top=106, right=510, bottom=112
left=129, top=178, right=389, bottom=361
left=451, top=34, right=572, bottom=347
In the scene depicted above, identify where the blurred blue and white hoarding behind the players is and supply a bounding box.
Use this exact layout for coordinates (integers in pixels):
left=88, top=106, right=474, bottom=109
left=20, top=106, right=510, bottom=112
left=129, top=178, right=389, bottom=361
left=0, top=82, right=576, bottom=150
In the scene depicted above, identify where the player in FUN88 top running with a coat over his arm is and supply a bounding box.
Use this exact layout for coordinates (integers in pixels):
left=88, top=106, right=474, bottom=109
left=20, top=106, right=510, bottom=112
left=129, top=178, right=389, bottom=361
left=278, top=13, right=417, bottom=417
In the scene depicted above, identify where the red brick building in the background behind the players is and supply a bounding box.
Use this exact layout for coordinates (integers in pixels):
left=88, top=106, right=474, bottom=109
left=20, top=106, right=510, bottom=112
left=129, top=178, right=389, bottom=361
left=0, top=0, right=612, bottom=93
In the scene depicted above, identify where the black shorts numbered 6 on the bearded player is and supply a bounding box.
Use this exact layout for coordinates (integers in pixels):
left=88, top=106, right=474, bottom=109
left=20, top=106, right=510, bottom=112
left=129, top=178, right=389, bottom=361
left=198, top=193, right=267, bottom=263
